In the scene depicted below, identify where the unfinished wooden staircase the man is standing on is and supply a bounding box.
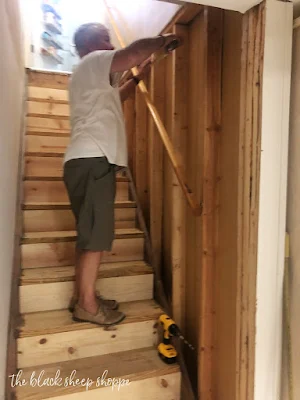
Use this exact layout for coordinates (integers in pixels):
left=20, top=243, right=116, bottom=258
left=14, top=71, right=181, bottom=400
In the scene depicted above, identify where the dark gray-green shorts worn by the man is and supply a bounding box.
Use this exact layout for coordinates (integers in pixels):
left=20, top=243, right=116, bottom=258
left=64, top=157, right=116, bottom=251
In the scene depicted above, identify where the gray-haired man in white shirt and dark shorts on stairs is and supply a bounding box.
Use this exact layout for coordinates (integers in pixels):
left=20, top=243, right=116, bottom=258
left=64, top=23, right=176, bottom=326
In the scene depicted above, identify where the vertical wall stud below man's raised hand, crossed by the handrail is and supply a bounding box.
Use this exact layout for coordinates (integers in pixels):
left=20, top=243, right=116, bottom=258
left=171, top=25, right=188, bottom=332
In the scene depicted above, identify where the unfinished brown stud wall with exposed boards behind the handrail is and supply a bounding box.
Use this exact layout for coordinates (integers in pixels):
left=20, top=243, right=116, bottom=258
left=125, top=8, right=242, bottom=400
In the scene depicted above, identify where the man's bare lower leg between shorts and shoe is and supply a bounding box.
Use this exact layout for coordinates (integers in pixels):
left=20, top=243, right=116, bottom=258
left=76, top=250, right=102, bottom=314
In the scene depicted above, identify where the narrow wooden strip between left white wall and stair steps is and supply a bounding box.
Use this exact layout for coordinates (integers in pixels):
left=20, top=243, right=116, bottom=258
left=5, top=72, right=27, bottom=400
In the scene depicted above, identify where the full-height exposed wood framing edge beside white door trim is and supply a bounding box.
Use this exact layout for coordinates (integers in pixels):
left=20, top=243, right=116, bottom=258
left=236, top=4, right=265, bottom=400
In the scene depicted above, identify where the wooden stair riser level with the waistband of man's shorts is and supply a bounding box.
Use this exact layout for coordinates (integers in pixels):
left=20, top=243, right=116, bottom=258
left=24, top=156, right=128, bottom=182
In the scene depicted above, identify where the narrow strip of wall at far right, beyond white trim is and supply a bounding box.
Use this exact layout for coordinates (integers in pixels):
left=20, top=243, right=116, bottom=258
left=281, top=21, right=300, bottom=400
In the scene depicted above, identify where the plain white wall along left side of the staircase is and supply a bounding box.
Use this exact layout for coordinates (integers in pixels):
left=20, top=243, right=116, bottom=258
left=0, top=0, right=24, bottom=399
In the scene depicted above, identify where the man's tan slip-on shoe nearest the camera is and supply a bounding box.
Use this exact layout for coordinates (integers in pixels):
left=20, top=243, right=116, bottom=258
left=73, top=303, right=125, bottom=326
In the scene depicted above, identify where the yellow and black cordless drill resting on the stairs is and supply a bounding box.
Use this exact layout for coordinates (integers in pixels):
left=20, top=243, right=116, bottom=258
left=157, top=314, right=194, bottom=364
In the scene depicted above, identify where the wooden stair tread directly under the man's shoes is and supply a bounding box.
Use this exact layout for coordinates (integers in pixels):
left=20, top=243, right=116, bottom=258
left=19, top=300, right=163, bottom=338
